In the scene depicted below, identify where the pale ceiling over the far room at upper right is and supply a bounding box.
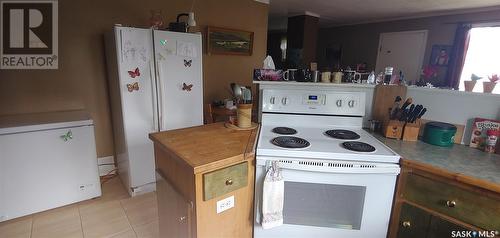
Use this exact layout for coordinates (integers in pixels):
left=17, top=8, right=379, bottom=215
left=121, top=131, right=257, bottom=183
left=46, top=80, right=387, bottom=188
left=269, top=0, right=500, bottom=30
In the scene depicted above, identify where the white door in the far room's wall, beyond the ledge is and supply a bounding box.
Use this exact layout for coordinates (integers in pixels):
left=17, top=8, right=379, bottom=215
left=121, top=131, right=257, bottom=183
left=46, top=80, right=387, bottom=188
left=376, top=30, right=427, bottom=82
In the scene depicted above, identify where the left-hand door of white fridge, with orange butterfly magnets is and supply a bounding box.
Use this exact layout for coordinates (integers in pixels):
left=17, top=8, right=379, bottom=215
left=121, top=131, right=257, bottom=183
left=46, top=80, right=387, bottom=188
left=115, top=27, right=158, bottom=188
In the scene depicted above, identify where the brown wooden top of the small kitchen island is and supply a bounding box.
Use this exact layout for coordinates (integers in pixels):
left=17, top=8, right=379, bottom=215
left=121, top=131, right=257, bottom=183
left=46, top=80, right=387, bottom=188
left=149, top=122, right=258, bottom=173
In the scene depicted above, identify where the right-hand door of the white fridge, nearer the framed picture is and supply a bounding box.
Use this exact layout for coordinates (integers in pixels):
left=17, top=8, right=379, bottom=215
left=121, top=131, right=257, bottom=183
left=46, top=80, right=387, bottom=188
left=154, top=31, right=203, bottom=131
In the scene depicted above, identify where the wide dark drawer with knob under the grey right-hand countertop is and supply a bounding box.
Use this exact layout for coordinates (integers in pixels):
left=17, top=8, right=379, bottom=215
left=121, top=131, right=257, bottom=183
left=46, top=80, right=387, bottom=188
left=402, top=173, right=500, bottom=230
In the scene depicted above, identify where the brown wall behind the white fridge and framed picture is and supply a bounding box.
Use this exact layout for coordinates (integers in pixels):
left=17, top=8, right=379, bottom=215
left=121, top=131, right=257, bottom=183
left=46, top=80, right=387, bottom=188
left=0, top=0, right=268, bottom=157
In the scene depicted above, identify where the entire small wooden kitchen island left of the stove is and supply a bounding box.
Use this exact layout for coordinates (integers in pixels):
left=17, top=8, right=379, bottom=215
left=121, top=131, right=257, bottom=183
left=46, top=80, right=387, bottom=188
left=149, top=123, right=258, bottom=238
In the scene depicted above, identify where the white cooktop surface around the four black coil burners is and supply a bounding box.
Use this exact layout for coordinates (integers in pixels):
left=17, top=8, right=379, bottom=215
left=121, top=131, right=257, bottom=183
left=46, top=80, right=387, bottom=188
left=257, top=114, right=400, bottom=163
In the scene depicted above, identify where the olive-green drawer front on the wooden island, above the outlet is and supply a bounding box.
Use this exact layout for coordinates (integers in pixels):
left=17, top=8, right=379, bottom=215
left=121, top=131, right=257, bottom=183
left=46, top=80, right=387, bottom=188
left=203, top=161, right=248, bottom=201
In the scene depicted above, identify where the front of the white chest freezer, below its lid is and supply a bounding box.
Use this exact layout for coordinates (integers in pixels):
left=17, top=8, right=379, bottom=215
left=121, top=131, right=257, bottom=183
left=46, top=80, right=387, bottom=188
left=0, top=126, right=101, bottom=221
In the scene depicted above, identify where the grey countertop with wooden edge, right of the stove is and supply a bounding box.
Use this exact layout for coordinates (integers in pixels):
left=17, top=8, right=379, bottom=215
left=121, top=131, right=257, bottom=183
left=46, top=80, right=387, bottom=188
left=374, top=134, right=500, bottom=192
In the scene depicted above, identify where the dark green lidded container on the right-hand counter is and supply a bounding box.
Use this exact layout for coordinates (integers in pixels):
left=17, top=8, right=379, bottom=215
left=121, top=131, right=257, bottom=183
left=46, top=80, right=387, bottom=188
left=422, top=122, right=457, bottom=147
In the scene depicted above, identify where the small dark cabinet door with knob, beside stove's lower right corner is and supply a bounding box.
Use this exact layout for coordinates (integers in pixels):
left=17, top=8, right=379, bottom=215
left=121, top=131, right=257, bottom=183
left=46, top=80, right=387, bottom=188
left=397, top=203, right=431, bottom=238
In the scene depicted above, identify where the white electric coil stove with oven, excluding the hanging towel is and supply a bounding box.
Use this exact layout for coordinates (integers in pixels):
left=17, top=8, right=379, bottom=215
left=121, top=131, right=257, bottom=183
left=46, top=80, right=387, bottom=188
left=254, top=87, right=400, bottom=238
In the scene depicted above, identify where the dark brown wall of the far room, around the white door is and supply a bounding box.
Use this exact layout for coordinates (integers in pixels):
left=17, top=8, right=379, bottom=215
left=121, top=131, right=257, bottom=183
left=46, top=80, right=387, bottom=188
left=317, top=10, right=500, bottom=69
